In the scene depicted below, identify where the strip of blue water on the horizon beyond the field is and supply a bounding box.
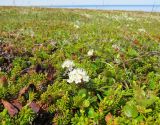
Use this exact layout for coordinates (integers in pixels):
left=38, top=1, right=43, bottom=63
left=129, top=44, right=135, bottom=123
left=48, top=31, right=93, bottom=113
left=48, top=5, right=160, bottom=12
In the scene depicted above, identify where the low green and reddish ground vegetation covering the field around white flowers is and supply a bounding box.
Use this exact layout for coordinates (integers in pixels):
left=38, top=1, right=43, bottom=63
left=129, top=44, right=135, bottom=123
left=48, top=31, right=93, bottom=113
left=0, top=7, right=160, bottom=125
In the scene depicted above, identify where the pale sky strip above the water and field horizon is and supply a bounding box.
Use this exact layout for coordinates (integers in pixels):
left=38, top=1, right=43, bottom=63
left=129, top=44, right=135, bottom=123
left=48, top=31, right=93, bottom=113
left=0, top=0, right=160, bottom=6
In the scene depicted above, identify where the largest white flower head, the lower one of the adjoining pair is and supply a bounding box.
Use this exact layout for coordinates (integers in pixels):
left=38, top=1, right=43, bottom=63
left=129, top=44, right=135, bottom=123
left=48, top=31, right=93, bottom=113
left=67, top=68, right=89, bottom=84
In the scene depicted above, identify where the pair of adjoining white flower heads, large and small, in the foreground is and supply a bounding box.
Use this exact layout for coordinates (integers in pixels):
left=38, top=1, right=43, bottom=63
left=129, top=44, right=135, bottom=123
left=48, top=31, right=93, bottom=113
left=62, top=60, right=89, bottom=84
